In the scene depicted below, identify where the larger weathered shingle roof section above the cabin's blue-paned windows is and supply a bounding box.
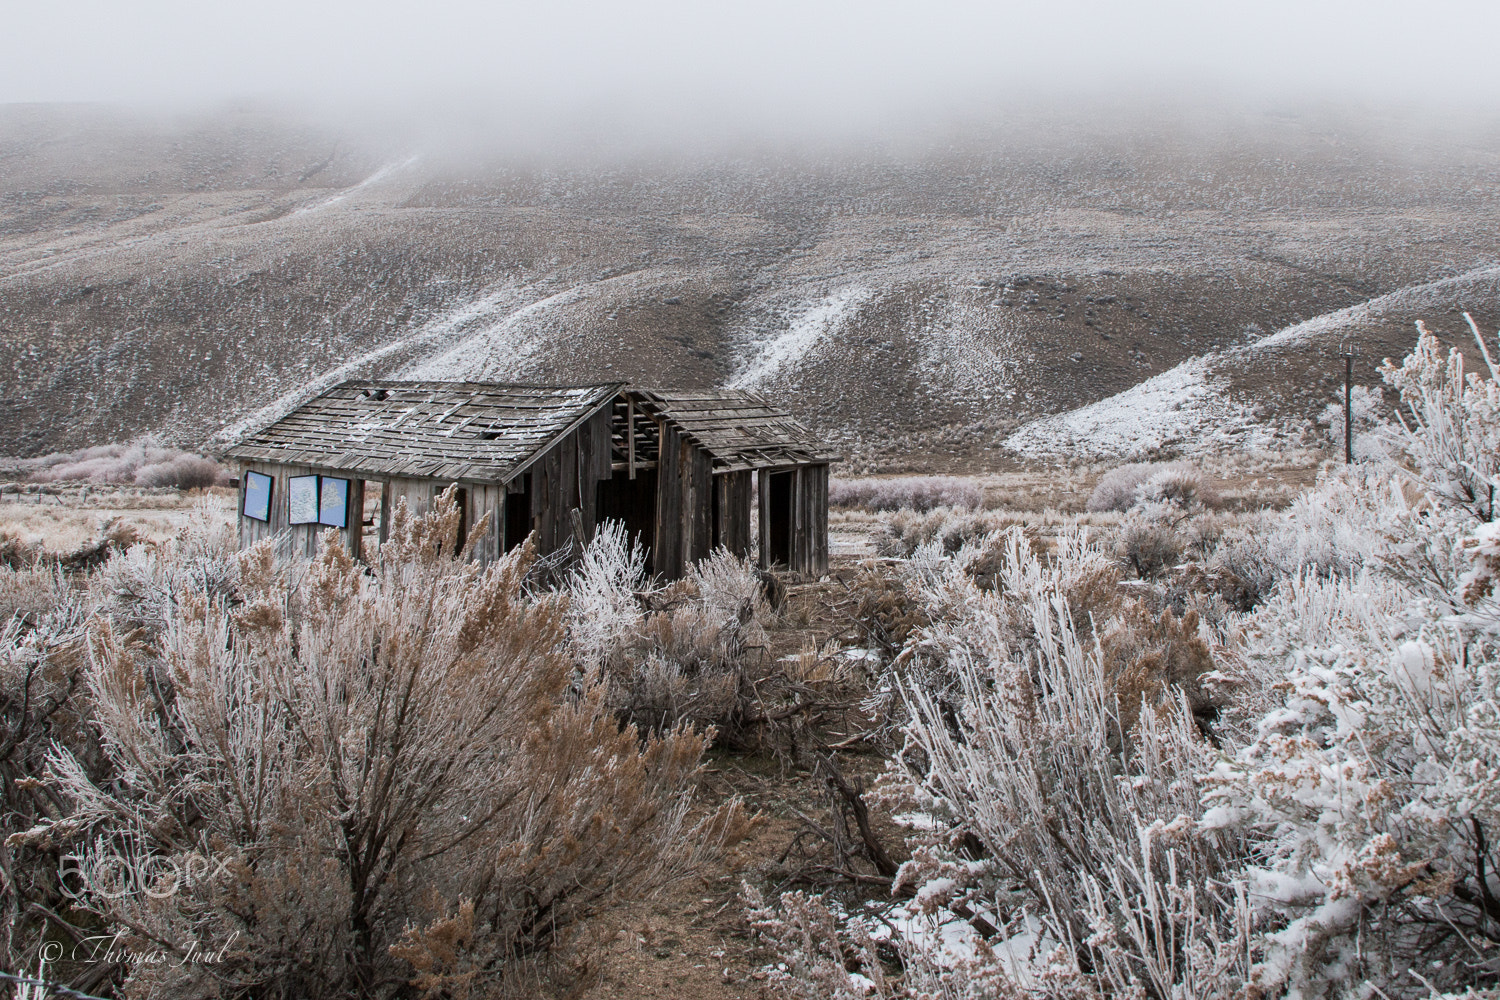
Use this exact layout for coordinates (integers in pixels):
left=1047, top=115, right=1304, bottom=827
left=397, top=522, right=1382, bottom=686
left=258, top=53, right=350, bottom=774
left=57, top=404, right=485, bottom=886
left=225, top=381, right=624, bottom=483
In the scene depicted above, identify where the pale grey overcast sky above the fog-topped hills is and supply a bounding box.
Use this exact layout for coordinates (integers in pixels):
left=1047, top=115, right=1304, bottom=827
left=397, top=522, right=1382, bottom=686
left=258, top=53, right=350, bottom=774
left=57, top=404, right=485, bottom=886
left=0, top=0, right=1500, bottom=117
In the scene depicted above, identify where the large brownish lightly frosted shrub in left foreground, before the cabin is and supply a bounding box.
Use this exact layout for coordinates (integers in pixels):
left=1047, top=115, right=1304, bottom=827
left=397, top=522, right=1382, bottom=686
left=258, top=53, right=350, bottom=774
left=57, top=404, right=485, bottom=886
left=11, top=492, right=741, bottom=999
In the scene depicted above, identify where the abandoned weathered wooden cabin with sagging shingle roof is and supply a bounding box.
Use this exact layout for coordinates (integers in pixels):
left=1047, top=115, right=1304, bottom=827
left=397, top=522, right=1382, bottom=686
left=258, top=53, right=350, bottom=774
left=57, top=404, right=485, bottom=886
left=225, top=381, right=837, bottom=579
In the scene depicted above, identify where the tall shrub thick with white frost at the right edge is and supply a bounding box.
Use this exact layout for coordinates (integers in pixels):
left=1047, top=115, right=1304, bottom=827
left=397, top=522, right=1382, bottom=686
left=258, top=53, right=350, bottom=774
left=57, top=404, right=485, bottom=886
left=1202, top=319, right=1500, bottom=997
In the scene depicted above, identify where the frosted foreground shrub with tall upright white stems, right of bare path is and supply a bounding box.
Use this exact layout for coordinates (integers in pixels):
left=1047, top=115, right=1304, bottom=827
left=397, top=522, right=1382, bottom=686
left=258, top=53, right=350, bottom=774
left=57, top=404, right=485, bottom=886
left=897, top=535, right=1247, bottom=997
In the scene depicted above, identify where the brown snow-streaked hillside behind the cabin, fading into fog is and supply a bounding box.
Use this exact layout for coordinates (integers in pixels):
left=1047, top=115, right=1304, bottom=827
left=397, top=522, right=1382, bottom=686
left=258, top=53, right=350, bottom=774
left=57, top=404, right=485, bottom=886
left=0, top=105, right=1500, bottom=465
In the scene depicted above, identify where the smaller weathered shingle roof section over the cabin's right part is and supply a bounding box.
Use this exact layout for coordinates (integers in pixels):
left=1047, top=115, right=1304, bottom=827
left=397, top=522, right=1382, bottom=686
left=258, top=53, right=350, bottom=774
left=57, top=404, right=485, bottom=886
left=630, top=388, right=839, bottom=472
